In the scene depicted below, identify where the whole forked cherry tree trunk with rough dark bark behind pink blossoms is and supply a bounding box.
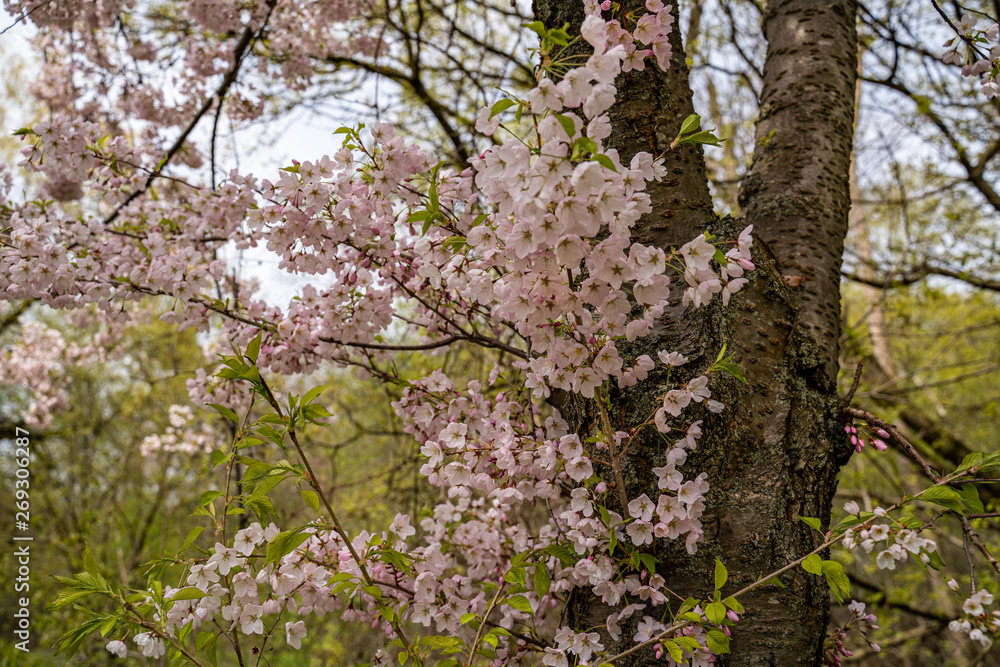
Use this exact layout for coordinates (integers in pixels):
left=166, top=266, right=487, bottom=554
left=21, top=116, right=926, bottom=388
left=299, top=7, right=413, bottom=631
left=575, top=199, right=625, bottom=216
left=535, top=0, right=857, bottom=667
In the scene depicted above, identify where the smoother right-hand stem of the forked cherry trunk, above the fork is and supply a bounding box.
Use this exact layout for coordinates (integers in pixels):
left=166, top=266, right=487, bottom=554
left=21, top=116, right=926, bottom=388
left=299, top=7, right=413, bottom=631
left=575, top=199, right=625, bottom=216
left=739, top=0, right=857, bottom=381
